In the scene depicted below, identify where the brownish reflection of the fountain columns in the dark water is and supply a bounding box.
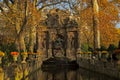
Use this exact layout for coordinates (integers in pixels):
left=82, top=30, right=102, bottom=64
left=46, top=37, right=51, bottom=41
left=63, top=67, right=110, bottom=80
left=40, top=69, right=79, bottom=80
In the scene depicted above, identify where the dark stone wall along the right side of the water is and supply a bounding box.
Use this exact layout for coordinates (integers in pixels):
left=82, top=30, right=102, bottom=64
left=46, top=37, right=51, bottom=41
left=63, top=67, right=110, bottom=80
left=77, top=58, right=120, bottom=79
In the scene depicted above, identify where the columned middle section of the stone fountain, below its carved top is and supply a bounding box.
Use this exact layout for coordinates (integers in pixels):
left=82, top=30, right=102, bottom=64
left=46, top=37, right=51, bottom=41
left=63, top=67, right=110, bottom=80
left=38, top=27, right=79, bottom=58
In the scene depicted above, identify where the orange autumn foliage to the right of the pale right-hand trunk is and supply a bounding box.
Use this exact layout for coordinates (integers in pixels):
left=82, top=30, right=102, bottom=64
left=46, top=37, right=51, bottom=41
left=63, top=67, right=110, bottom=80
left=99, top=0, right=119, bottom=46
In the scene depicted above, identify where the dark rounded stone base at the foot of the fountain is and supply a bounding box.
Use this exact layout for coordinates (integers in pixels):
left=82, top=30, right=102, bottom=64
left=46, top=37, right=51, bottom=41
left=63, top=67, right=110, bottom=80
left=41, top=57, right=79, bottom=71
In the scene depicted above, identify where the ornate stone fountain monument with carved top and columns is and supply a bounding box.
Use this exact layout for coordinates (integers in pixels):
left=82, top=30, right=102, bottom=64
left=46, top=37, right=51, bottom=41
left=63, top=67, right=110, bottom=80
left=38, top=9, right=79, bottom=57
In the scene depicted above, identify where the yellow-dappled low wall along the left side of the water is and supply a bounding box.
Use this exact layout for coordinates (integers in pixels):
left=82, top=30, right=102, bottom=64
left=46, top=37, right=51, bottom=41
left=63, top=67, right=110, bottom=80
left=3, top=54, right=43, bottom=80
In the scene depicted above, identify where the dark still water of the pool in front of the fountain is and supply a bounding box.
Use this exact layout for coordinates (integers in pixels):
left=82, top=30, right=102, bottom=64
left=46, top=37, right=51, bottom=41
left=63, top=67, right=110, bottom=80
left=28, top=69, right=117, bottom=80
